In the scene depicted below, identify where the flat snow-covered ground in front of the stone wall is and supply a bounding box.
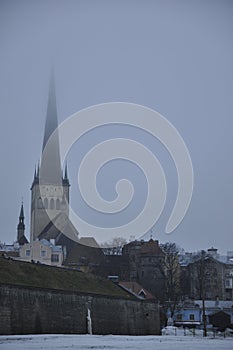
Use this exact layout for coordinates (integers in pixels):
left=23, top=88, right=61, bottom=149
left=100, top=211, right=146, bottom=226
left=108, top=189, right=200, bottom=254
left=0, top=335, right=233, bottom=350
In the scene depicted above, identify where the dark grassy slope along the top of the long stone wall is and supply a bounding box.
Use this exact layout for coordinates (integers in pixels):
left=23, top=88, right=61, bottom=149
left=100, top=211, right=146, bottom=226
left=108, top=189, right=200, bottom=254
left=0, top=258, right=130, bottom=298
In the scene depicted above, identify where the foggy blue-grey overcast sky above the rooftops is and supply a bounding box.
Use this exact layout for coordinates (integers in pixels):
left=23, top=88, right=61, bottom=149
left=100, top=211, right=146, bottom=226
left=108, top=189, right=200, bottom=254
left=0, top=0, right=233, bottom=252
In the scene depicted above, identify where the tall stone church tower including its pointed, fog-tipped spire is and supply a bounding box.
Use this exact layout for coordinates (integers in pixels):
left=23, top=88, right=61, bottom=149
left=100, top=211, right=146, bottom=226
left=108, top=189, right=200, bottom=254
left=30, top=74, right=70, bottom=242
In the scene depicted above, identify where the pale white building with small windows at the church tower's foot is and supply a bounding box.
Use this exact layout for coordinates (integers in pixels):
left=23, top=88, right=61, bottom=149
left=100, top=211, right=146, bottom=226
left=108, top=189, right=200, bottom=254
left=19, top=239, right=64, bottom=266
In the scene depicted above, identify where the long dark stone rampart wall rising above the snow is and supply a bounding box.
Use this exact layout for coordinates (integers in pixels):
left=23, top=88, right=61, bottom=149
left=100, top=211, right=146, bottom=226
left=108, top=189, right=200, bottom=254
left=0, top=285, right=160, bottom=335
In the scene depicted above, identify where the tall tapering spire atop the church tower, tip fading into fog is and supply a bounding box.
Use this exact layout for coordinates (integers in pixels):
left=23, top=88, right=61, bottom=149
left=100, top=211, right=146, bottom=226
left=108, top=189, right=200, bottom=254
left=38, top=70, right=61, bottom=185
